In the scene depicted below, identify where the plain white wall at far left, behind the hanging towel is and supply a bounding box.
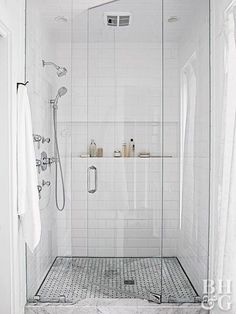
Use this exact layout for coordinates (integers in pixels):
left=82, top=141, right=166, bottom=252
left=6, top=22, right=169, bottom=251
left=0, top=0, right=25, bottom=314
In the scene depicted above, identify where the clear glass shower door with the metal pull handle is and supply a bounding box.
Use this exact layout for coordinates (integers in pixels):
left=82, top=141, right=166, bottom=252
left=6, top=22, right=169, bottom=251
left=86, top=0, right=162, bottom=303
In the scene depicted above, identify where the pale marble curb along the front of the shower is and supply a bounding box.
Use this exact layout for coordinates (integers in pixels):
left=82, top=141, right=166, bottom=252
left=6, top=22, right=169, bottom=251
left=25, top=299, right=208, bottom=314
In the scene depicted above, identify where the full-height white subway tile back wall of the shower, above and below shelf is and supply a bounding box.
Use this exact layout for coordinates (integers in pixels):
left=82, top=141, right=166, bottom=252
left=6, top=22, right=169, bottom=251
left=66, top=25, right=179, bottom=257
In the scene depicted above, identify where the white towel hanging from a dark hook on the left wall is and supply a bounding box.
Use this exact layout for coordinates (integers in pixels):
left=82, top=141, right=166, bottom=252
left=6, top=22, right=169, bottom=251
left=17, top=85, right=41, bottom=252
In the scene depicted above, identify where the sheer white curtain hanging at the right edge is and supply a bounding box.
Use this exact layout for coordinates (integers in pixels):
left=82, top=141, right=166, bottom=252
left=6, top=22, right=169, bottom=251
left=212, top=9, right=236, bottom=313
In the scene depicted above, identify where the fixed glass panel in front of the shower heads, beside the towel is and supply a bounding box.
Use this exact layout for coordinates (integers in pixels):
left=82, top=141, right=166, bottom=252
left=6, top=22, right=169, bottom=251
left=26, top=0, right=72, bottom=302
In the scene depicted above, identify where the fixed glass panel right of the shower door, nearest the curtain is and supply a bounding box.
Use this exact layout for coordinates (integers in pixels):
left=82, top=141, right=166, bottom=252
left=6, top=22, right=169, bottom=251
left=162, top=0, right=210, bottom=302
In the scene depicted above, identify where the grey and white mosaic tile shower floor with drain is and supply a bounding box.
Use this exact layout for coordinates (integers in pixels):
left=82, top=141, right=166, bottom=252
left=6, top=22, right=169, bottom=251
left=36, top=257, right=198, bottom=303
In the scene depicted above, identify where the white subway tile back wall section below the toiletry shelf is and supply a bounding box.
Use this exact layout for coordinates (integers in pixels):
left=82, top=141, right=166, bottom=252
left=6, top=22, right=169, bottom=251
left=72, top=157, right=179, bottom=257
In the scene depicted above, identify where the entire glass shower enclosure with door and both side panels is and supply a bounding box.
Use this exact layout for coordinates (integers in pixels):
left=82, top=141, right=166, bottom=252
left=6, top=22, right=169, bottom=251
left=26, top=0, right=210, bottom=304
